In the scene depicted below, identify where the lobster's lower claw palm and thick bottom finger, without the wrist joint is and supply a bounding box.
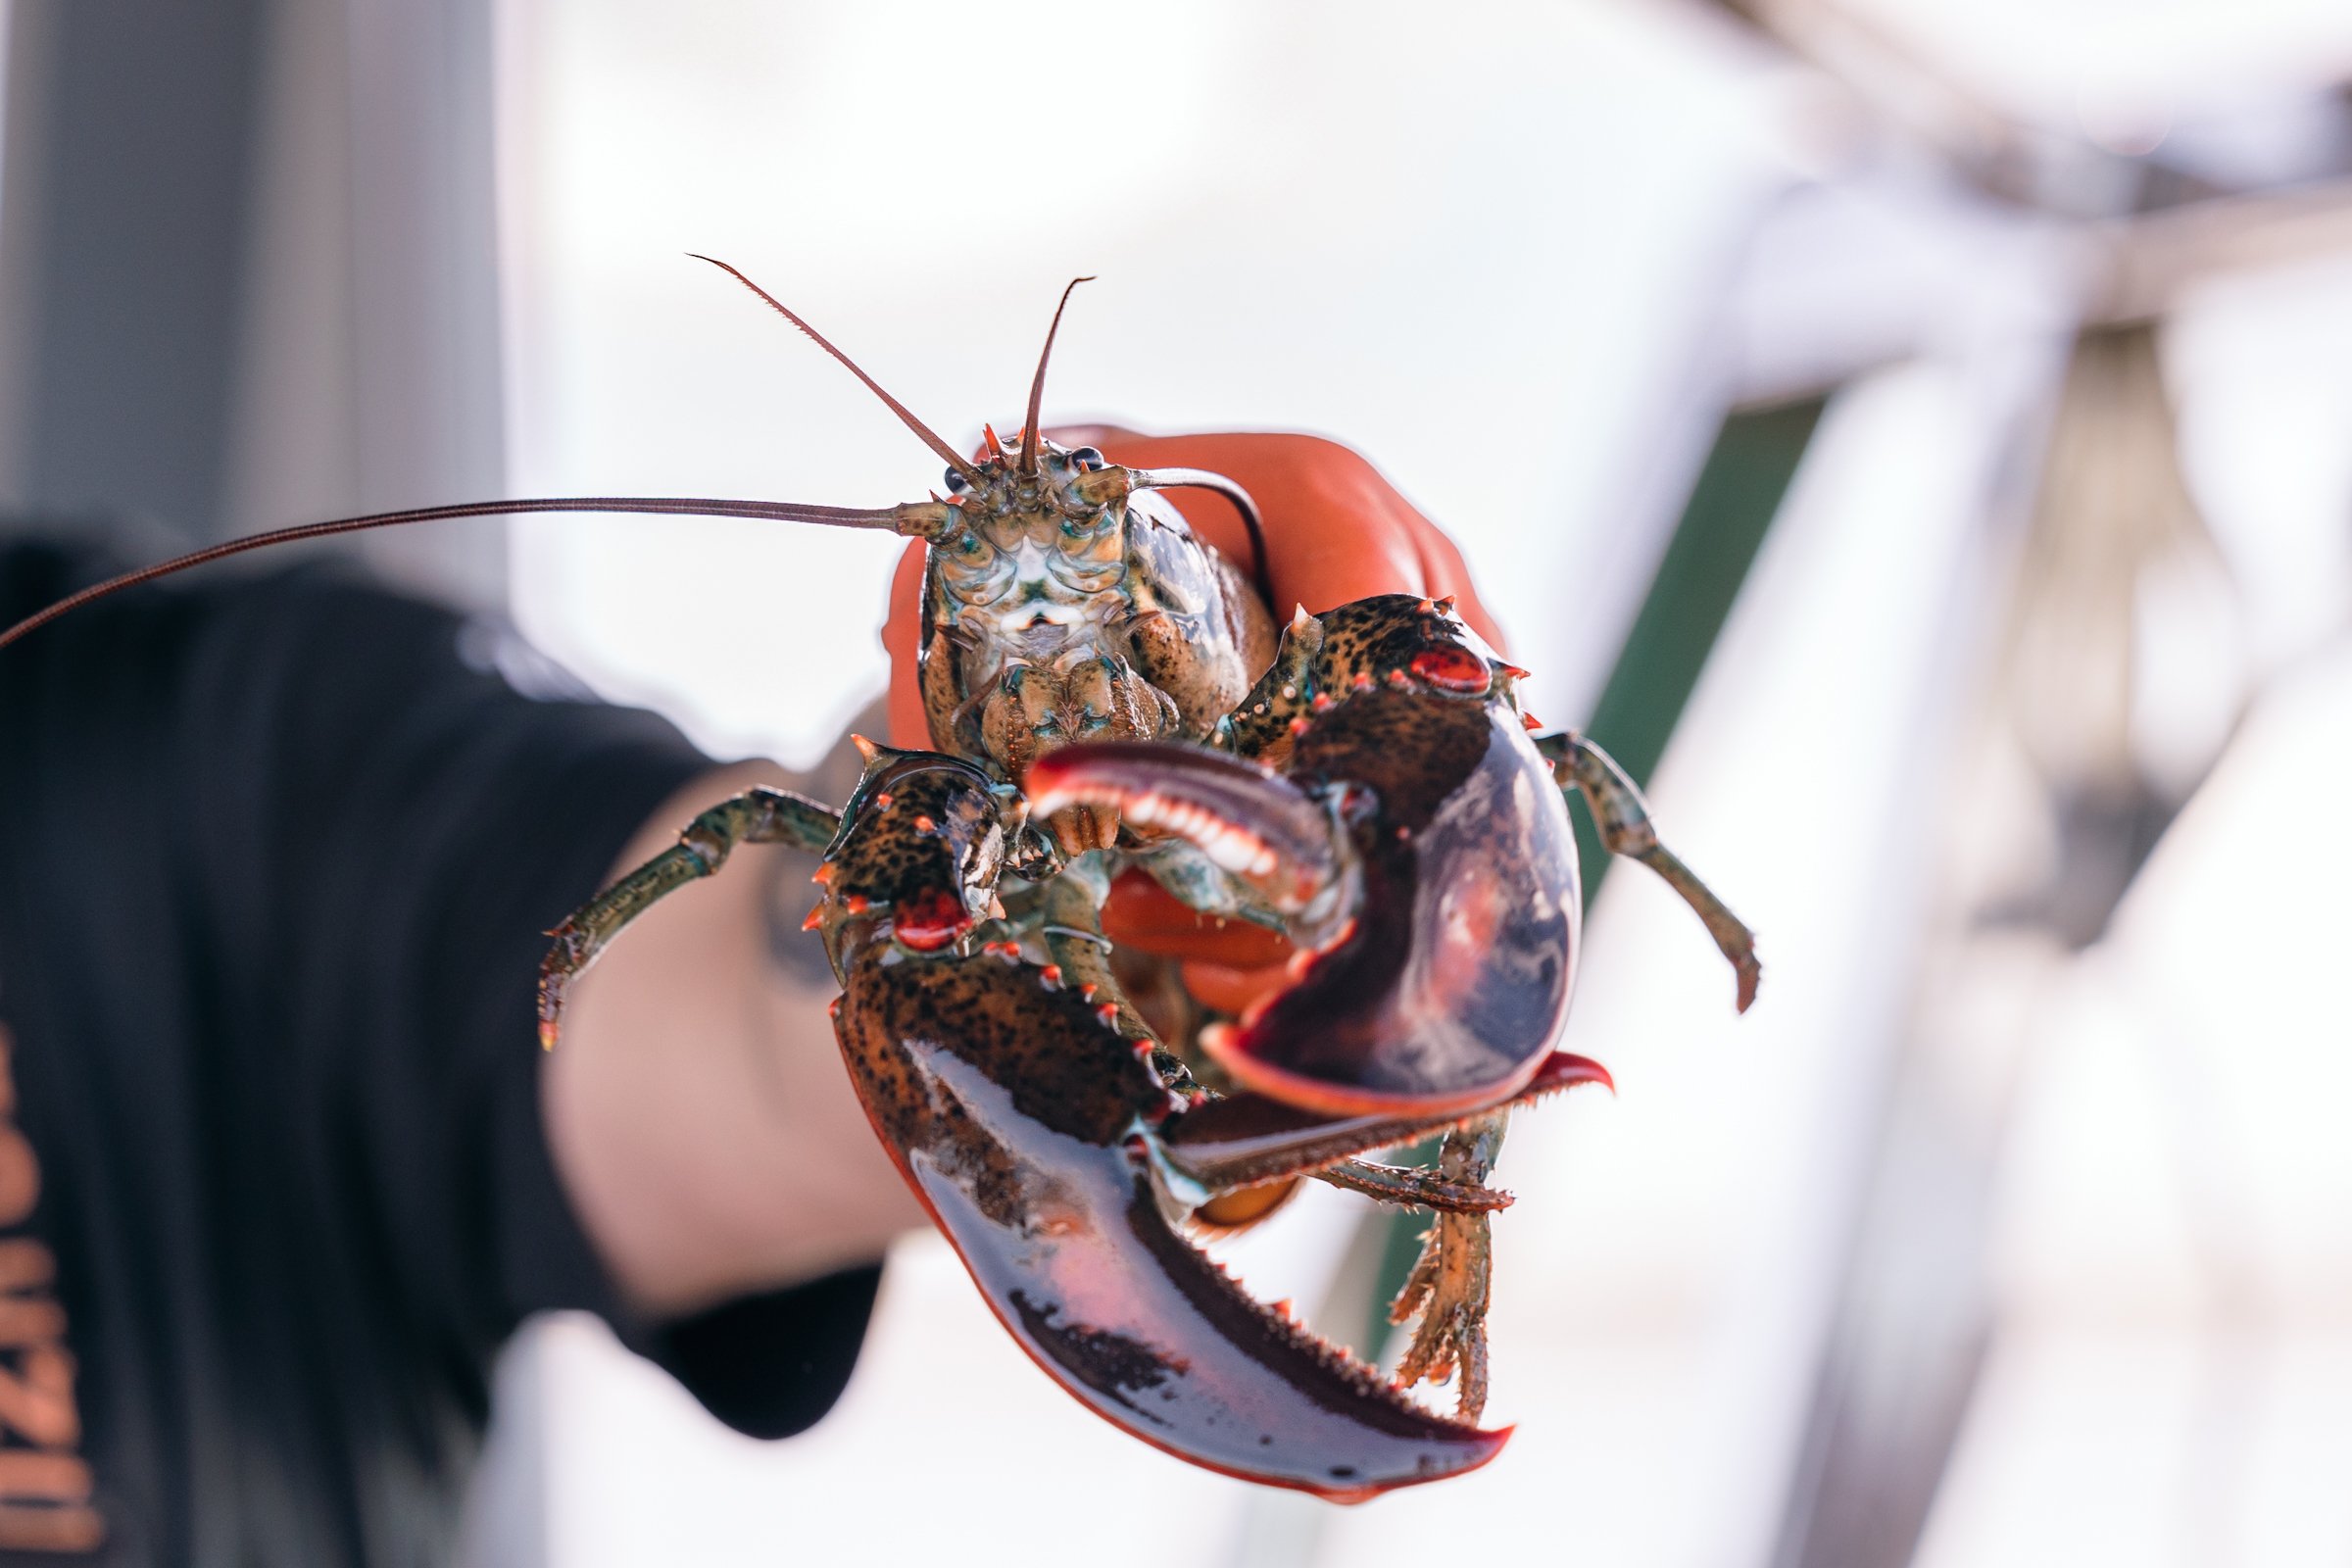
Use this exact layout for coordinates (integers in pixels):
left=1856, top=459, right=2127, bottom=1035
left=835, top=943, right=1510, bottom=1502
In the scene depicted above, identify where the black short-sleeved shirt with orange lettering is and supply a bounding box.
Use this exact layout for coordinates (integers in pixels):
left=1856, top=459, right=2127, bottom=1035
left=0, top=548, right=877, bottom=1568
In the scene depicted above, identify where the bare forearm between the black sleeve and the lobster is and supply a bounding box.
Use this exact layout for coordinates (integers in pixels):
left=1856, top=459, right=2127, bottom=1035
left=541, top=764, right=924, bottom=1316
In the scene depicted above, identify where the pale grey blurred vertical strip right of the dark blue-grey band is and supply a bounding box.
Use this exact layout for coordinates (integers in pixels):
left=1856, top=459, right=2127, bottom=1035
left=235, top=0, right=506, bottom=609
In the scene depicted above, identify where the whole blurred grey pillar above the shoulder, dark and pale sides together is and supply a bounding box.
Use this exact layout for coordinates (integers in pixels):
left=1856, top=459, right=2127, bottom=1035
left=0, top=0, right=506, bottom=607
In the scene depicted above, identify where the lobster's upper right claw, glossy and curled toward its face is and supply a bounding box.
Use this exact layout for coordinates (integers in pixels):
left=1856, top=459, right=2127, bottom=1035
left=1028, top=681, right=1581, bottom=1116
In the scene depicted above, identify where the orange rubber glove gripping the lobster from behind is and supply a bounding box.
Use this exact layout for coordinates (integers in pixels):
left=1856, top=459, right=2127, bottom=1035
left=882, top=425, right=1503, bottom=1013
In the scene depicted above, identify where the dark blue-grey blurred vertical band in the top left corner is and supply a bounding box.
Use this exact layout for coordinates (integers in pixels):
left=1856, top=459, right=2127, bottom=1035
left=0, top=0, right=261, bottom=541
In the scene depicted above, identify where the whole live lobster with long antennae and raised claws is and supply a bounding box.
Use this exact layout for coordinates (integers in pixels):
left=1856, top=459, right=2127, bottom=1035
left=0, top=256, right=1759, bottom=1502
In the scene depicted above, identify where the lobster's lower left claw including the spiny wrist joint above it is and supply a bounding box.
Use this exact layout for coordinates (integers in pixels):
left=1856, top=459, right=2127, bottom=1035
left=816, top=748, right=1507, bottom=1499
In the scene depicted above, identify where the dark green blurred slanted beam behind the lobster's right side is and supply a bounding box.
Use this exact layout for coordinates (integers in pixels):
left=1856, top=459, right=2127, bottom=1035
left=1357, top=397, right=1828, bottom=1361
